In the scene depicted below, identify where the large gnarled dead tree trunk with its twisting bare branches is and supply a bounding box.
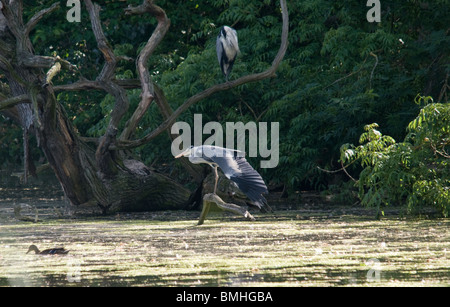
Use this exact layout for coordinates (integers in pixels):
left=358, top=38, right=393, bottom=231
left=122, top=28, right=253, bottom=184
left=0, top=0, right=288, bottom=212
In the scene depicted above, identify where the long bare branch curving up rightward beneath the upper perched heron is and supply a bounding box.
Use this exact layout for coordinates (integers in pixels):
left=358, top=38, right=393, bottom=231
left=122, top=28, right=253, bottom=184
left=116, top=0, right=289, bottom=149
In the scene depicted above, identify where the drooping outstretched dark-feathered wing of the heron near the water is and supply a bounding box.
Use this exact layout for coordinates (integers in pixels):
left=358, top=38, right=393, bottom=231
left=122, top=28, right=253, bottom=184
left=210, top=149, right=272, bottom=211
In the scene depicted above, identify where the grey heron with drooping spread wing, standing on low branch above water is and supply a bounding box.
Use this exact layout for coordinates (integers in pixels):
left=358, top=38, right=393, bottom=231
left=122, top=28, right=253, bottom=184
left=175, top=145, right=272, bottom=211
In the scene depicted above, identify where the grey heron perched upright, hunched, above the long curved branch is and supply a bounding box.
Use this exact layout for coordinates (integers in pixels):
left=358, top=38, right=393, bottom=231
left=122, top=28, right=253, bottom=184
left=216, top=26, right=239, bottom=81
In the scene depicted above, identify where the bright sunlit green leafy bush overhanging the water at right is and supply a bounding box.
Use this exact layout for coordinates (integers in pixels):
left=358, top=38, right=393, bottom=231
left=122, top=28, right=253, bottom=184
left=341, top=97, right=450, bottom=217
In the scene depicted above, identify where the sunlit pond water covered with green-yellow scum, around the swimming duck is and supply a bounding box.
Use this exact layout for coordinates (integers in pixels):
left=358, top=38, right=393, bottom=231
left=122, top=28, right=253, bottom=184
left=0, top=170, right=450, bottom=287
